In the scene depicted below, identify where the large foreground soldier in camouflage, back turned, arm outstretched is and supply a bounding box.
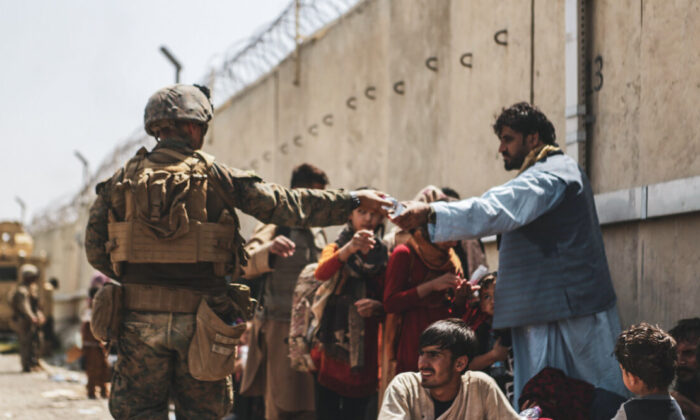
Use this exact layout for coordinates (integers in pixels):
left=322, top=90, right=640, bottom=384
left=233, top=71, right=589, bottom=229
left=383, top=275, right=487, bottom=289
left=85, top=84, right=391, bottom=419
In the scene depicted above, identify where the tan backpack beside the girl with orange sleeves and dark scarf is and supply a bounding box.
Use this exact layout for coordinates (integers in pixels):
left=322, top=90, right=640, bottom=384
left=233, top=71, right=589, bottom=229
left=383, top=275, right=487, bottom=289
left=287, top=262, right=341, bottom=372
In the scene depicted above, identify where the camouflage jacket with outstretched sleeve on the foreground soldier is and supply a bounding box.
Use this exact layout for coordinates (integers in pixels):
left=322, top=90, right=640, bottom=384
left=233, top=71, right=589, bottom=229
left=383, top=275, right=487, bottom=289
left=85, top=141, right=352, bottom=289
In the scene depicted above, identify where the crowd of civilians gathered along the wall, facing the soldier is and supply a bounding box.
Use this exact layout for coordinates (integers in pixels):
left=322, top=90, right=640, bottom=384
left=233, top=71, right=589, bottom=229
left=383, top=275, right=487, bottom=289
left=228, top=103, right=700, bottom=420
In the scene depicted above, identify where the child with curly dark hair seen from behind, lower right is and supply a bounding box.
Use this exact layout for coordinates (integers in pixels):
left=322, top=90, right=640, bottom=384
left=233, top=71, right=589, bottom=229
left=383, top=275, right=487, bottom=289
left=612, top=322, right=683, bottom=420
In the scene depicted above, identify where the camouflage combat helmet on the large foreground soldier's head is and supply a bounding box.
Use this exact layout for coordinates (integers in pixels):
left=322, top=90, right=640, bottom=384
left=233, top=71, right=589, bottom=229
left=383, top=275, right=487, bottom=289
left=143, top=84, right=214, bottom=137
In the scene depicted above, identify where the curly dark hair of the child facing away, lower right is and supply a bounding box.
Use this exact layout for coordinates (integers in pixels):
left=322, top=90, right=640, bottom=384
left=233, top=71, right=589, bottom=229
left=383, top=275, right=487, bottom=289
left=615, top=322, right=677, bottom=390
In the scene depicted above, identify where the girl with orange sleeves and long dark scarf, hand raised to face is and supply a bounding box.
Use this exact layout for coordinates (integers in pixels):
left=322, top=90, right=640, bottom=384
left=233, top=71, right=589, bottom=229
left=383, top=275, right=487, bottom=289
left=312, top=199, right=388, bottom=420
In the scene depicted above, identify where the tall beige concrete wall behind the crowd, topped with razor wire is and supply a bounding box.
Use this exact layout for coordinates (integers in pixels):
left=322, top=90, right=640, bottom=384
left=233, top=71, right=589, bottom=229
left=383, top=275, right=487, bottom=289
left=207, top=0, right=700, bottom=328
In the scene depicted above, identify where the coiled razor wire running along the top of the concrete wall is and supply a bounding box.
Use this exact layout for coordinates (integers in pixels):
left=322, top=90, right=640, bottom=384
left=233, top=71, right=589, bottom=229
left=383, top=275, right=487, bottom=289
left=29, top=0, right=362, bottom=232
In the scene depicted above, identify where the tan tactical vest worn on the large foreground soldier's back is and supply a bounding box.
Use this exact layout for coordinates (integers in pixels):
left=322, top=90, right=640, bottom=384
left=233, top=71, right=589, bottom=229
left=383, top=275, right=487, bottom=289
left=106, top=148, right=244, bottom=276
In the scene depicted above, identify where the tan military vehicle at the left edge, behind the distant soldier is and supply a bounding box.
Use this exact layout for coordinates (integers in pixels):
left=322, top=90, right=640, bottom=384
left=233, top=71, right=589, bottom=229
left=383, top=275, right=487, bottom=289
left=0, top=222, right=53, bottom=333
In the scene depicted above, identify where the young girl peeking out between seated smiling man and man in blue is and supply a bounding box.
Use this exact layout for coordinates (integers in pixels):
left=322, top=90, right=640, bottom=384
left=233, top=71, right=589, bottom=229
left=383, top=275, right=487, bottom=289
left=463, top=272, right=513, bottom=399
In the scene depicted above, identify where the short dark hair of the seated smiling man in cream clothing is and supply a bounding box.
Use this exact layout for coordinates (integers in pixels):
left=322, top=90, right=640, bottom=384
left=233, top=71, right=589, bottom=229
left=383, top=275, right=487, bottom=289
left=418, top=318, right=478, bottom=360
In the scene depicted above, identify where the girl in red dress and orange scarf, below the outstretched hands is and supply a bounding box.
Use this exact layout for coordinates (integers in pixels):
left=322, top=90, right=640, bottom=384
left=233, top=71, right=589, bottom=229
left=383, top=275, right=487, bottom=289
left=384, top=230, right=463, bottom=374
